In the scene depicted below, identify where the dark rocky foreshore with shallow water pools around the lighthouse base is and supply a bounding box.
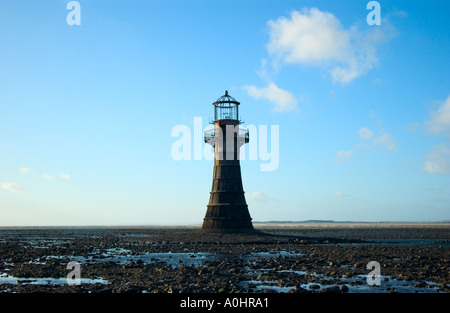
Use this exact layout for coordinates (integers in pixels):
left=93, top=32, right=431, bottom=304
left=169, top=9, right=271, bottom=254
left=0, top=227, right=450, bottom=293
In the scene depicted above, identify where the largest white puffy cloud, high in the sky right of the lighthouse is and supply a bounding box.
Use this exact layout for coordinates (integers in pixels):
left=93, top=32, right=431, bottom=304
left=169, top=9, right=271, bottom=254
left=267, top=8, right=391, bottom=83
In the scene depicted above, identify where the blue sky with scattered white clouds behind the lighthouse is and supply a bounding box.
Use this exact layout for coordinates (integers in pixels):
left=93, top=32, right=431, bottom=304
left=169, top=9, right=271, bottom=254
left=0, top=0, right=450, bottom=226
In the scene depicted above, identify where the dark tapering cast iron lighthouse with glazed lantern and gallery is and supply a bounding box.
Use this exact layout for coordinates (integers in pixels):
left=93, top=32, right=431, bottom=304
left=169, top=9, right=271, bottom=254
left=202, top=91, right=253, bottom=231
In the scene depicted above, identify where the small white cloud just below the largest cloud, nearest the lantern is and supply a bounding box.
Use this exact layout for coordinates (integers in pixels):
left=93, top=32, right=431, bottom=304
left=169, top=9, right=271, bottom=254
left=244, top=82, right=297, bottom=112
